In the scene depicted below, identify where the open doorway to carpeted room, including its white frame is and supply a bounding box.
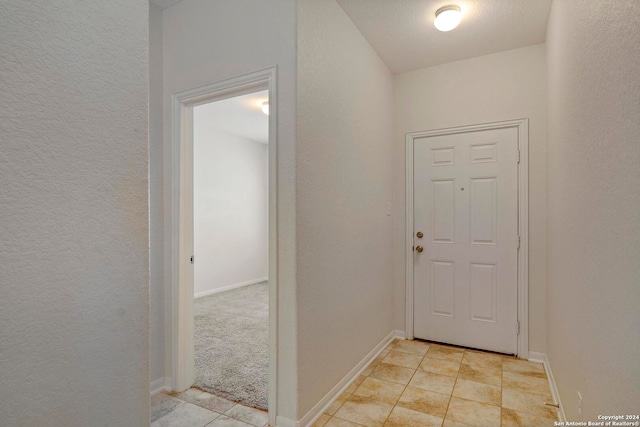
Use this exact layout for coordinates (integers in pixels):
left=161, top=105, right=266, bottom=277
left=171, top=67, right=277, bottom=422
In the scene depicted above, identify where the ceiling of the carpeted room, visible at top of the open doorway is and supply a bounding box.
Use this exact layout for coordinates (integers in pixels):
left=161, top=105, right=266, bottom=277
left=193, top=90, right=269, bottom=144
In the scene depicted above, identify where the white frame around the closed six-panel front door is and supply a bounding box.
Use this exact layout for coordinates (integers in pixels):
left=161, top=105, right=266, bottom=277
left=405, top=119, right=529, bottom=359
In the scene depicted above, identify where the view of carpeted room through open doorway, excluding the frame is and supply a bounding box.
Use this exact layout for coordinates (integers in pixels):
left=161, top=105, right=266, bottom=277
left=193, top=90, right=269, bottom=410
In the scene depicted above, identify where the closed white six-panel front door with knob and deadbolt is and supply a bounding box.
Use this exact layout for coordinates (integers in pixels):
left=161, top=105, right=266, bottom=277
left=413, top=128, right=519, bottom=354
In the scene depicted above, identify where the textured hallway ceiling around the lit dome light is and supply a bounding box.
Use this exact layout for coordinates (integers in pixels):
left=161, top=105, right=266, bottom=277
left=337, top=0, right=552, bottom=73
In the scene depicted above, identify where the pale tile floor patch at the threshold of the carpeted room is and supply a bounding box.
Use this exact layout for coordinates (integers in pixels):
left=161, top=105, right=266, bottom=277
left=151, top=388, right=269, bottom=427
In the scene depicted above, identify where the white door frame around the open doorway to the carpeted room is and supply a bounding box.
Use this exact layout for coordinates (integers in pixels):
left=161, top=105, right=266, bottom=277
left=170, top=66, right=278, bottom=425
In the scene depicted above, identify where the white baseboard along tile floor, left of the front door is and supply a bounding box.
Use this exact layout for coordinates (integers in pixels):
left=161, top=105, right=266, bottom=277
left=298, top=331, right=404, bottom=427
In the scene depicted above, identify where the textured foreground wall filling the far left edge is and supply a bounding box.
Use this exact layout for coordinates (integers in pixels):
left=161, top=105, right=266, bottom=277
left=0, top=0, right=149, bottom=426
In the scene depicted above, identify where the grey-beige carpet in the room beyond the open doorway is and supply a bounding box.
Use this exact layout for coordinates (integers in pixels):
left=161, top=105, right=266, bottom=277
left=194, top=282, right=269, bottom=410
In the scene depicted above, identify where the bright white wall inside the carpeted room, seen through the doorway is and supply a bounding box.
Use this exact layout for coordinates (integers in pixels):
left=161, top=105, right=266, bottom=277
left=193, top=127, right=269, bottom=296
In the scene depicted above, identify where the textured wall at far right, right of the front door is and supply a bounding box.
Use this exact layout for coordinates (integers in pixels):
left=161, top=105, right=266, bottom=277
left=547, top=0, right=640, bottom=421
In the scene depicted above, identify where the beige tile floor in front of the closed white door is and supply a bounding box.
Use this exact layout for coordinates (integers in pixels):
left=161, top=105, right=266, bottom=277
left=314, top=340, right=557, bottom=427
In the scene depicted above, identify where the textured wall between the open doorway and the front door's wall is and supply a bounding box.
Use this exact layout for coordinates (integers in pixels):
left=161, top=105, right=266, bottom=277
left=296, top=0, right=393, bottom=417
